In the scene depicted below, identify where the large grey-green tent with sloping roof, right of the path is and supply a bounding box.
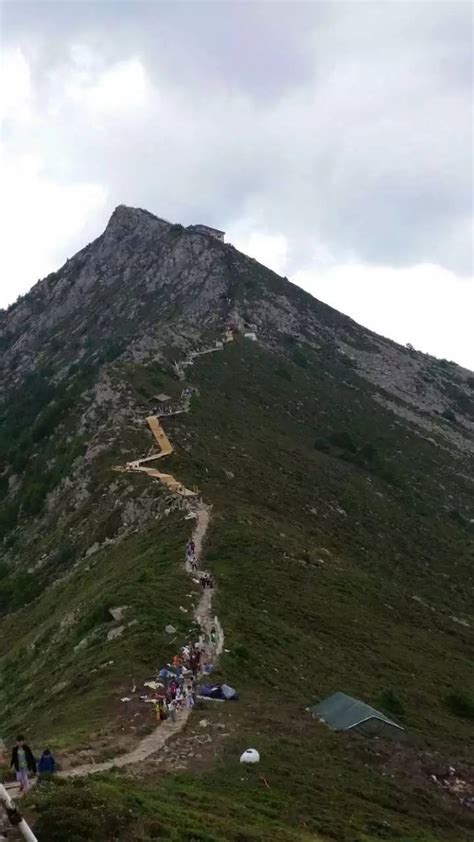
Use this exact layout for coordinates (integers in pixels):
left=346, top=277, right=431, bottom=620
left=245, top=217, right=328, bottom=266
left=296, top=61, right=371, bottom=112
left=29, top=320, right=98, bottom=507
left=310, top=693, right=405, bottom=740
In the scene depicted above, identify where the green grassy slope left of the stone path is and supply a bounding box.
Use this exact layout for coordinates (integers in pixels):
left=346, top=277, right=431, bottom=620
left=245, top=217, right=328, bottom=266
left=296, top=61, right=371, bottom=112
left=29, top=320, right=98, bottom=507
left=1, top=508, right=193, bottom=749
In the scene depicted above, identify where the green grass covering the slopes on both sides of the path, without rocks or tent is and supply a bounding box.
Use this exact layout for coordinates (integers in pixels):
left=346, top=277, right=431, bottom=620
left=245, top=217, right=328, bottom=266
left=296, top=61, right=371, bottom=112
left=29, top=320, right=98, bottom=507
left=0, top=340, right=472, bottom=842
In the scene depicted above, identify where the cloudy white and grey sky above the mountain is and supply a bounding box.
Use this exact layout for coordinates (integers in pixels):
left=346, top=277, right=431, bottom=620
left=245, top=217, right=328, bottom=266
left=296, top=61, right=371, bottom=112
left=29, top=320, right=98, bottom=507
left=0, top=0, right=474, bottom=368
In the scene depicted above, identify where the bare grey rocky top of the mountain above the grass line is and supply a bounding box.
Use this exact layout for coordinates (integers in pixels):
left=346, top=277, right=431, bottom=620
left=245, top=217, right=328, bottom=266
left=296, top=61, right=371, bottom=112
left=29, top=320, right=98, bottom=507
left=0, top=205, right=474, bottom=443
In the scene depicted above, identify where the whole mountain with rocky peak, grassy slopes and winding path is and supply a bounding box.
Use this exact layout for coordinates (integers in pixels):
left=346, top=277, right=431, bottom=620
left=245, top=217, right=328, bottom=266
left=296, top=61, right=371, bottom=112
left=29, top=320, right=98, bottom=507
left=0, top=206, right=474, bottom=842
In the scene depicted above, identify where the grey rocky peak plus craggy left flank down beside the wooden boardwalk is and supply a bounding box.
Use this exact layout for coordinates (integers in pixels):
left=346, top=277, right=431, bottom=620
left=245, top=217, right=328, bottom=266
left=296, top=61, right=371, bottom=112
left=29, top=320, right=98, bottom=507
left=0, top=205, right=474, bottom=608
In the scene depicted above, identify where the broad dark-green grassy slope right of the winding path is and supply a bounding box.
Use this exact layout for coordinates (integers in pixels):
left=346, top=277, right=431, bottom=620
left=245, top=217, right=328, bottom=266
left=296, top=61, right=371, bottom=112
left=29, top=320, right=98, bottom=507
left=4, top=342, right=469, bottom=842
